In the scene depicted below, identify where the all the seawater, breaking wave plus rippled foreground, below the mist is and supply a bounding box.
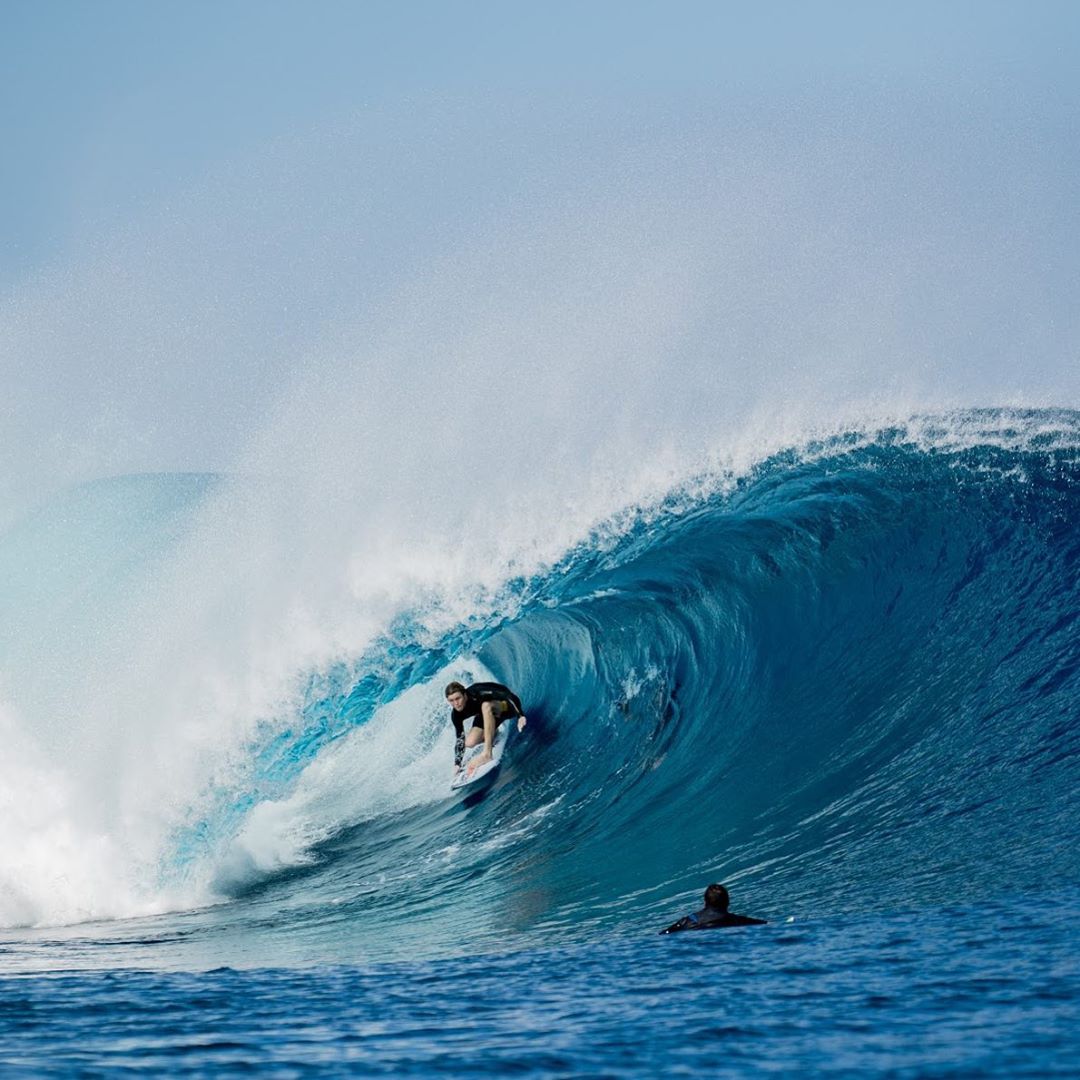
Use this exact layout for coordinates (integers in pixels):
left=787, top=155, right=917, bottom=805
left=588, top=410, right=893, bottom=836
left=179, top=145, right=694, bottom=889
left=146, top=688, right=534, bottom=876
left=0, top=409, right=1080, bottom=1077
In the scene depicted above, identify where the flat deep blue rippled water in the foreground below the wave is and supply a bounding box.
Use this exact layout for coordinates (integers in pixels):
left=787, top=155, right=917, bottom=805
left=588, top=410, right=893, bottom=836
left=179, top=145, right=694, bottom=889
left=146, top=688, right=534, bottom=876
left=0, top=890, right=1080, bottom=1077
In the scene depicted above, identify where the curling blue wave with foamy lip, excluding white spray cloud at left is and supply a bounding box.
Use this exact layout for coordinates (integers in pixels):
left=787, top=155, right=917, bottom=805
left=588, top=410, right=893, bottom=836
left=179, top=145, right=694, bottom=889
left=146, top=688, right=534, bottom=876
left=5, top=411, right=1080, bottom=961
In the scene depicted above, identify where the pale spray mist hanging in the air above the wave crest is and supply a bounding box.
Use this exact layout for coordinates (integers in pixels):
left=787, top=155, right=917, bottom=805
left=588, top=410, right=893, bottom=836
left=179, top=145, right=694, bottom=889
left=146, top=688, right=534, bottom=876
left=0, top=95, right=1080, bottom=532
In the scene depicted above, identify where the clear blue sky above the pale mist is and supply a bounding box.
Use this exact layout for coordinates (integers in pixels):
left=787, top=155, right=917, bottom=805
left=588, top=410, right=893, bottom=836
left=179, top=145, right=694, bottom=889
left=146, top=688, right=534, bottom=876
left=0, top=0, right=1080, bottom=286
